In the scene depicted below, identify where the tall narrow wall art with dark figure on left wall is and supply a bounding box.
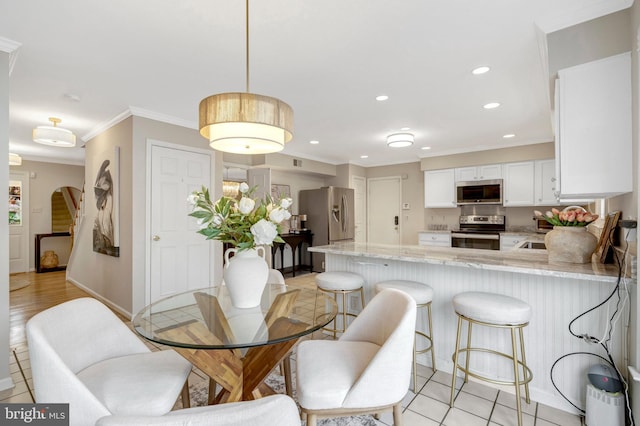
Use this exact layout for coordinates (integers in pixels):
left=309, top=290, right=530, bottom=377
left=93, top=147, right=120, bottom=257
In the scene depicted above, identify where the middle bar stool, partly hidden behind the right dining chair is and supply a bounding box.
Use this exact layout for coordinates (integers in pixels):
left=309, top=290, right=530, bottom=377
left=375, top=280, right=436, bottom=393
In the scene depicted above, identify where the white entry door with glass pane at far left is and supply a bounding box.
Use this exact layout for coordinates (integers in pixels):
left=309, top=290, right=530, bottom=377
left=5, top=172, right=29, bottom=274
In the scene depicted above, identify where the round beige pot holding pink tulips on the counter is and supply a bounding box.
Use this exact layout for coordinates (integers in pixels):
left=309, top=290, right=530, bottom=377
left=544, top=226, right=598, bottom=263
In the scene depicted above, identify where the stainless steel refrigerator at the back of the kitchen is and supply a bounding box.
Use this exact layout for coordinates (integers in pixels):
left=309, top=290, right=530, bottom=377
left=298, top=186, right=355, bottom=272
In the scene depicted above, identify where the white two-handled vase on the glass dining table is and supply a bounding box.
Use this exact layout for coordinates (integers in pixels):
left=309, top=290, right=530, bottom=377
left=223, top=247, right=269, bottom=308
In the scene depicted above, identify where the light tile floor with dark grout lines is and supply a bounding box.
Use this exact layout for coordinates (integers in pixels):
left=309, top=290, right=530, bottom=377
left=0, top=274, right=584, bottom=426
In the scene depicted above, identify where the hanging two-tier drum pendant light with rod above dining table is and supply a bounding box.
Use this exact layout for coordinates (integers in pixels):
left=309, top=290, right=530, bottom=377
left=199, top=0, right=293, bottom=154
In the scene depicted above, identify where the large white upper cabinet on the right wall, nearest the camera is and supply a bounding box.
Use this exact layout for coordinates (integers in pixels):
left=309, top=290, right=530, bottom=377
left=555, top=53, right=633, bottom=199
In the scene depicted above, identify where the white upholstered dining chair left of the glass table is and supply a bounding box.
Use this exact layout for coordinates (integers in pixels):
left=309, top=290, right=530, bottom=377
left=27, top=298, right=191, bottom=426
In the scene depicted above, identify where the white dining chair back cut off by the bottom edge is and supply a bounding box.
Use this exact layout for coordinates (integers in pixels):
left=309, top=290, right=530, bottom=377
left=96, top=395, right=300, bottom=426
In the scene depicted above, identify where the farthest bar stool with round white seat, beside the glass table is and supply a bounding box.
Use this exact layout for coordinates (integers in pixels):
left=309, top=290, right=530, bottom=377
left=316, top=271, right=364, bottom=339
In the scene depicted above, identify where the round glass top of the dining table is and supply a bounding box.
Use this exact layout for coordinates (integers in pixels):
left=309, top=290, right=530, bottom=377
left=133, top=284, right=337, bottom=349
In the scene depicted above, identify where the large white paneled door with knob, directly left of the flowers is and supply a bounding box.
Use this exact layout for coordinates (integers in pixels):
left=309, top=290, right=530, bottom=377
left=147, top=145, right=213, bottom=303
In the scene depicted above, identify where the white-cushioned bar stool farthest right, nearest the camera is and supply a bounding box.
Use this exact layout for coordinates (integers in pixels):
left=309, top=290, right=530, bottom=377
left=449, top=292, right=533, bottom=426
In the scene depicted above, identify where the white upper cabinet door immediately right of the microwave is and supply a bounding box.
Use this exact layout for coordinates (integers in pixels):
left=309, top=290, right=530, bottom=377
left=502, top=161, right=534, bottom=207
